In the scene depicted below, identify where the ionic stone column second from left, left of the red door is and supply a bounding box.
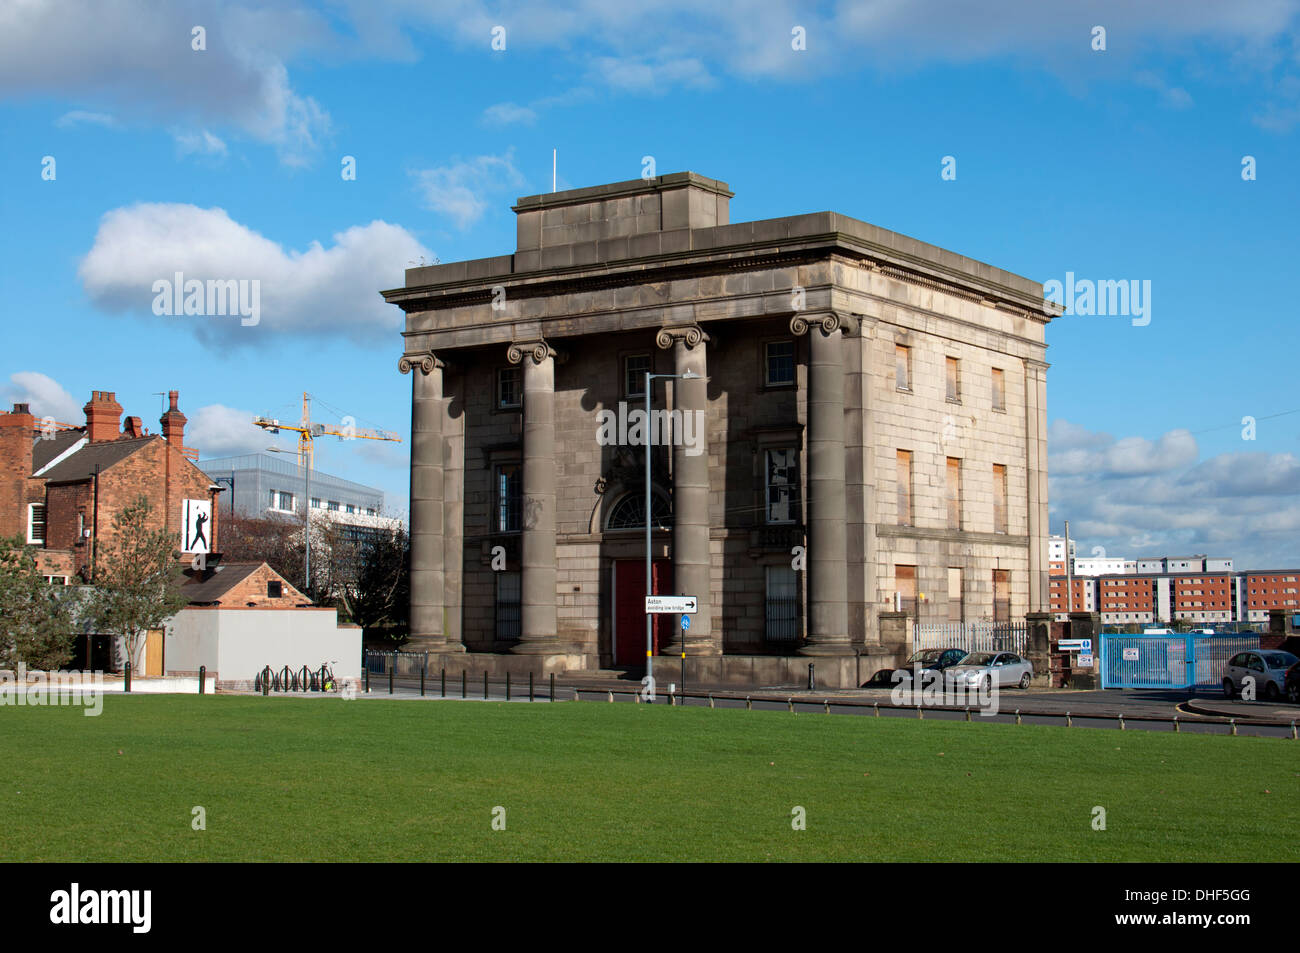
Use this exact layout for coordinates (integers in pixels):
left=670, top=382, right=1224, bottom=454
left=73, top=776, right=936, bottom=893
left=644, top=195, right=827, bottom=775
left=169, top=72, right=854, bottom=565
left=507, top=341, right=560, bottom=655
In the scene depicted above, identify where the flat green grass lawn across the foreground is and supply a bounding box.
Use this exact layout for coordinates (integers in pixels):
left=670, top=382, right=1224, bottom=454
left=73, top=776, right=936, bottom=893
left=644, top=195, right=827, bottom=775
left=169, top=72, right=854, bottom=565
left=0, top=696, right=1300, bottom=861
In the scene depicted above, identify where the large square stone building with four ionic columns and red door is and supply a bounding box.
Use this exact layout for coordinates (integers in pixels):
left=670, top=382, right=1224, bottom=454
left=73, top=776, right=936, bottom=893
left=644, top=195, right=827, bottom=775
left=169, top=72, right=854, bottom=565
left=384, top=173, right=1053, bottom=685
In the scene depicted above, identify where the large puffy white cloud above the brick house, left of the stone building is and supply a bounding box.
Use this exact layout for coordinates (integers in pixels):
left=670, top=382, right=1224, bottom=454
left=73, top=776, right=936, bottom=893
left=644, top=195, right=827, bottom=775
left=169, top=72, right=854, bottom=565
left=78, top=203, right=433, bottom=343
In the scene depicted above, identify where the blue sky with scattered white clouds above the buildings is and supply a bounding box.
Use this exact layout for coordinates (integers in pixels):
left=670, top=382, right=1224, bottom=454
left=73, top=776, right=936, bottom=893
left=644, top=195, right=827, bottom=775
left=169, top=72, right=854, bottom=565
left=0, top=0, right=1300, bottom=568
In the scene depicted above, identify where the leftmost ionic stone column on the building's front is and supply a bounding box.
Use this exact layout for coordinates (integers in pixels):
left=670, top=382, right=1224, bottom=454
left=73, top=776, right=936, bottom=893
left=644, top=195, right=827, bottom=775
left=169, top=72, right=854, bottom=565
left=398, top=351, right=465, bottom=651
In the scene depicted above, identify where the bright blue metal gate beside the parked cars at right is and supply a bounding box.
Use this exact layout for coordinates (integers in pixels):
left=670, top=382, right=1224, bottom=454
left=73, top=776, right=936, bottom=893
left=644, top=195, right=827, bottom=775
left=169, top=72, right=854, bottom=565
left=1101, top=632, right=1260, bottom=689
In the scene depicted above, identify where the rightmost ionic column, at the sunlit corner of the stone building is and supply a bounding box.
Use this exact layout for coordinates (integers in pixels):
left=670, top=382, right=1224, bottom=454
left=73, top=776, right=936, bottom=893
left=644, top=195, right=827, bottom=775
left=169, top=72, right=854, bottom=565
left=790, top=312, right=854, bottom=655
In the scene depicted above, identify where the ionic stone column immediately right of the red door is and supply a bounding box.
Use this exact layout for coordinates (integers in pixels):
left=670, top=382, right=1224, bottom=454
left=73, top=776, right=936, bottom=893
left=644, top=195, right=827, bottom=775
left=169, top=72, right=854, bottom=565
left=646, top=326, right=723, bottom=657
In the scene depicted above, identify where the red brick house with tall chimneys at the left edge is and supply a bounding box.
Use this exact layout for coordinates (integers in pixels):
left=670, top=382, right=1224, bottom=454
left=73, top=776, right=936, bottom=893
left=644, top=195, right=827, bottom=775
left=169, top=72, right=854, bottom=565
left=0, top=390, right=222, bottom=582
